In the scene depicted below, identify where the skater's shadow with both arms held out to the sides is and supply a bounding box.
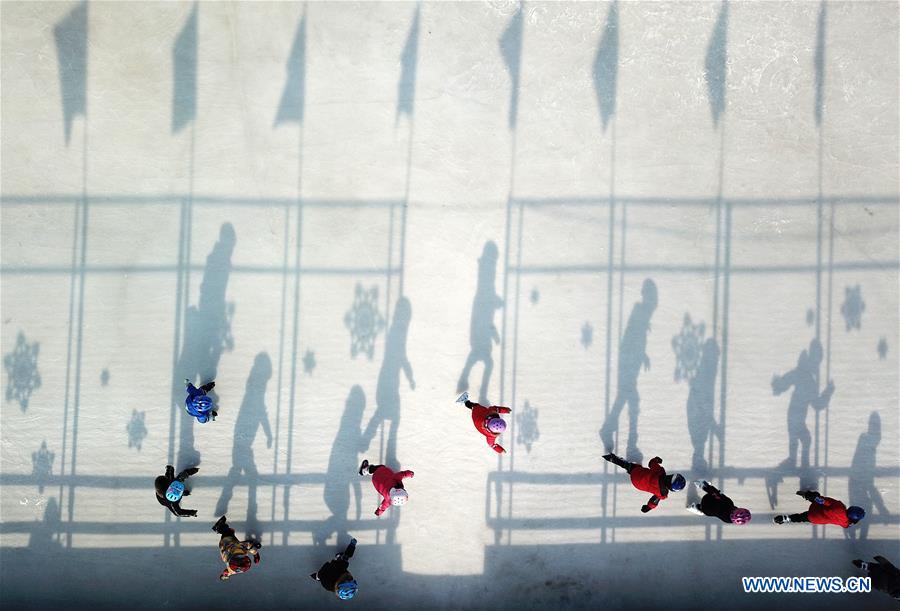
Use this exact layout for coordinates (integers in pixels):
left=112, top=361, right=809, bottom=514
left=772, top=339, right=834, bottom=469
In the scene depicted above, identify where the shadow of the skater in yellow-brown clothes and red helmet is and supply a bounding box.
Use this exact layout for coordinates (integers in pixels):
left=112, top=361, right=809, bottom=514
left=215, top=352, right=272, bottom=539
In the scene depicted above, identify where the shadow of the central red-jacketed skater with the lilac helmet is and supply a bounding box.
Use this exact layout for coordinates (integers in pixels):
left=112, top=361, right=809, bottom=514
left=456, top=241, right=503, bottom=405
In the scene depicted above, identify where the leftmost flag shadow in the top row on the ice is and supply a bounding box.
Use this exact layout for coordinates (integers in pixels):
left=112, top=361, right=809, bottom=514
left=53, top=2, right=87, bottom=145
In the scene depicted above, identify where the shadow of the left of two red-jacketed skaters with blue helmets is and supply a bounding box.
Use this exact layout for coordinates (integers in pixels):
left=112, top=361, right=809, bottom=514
left=600, top=278, right=657, bottom=463
